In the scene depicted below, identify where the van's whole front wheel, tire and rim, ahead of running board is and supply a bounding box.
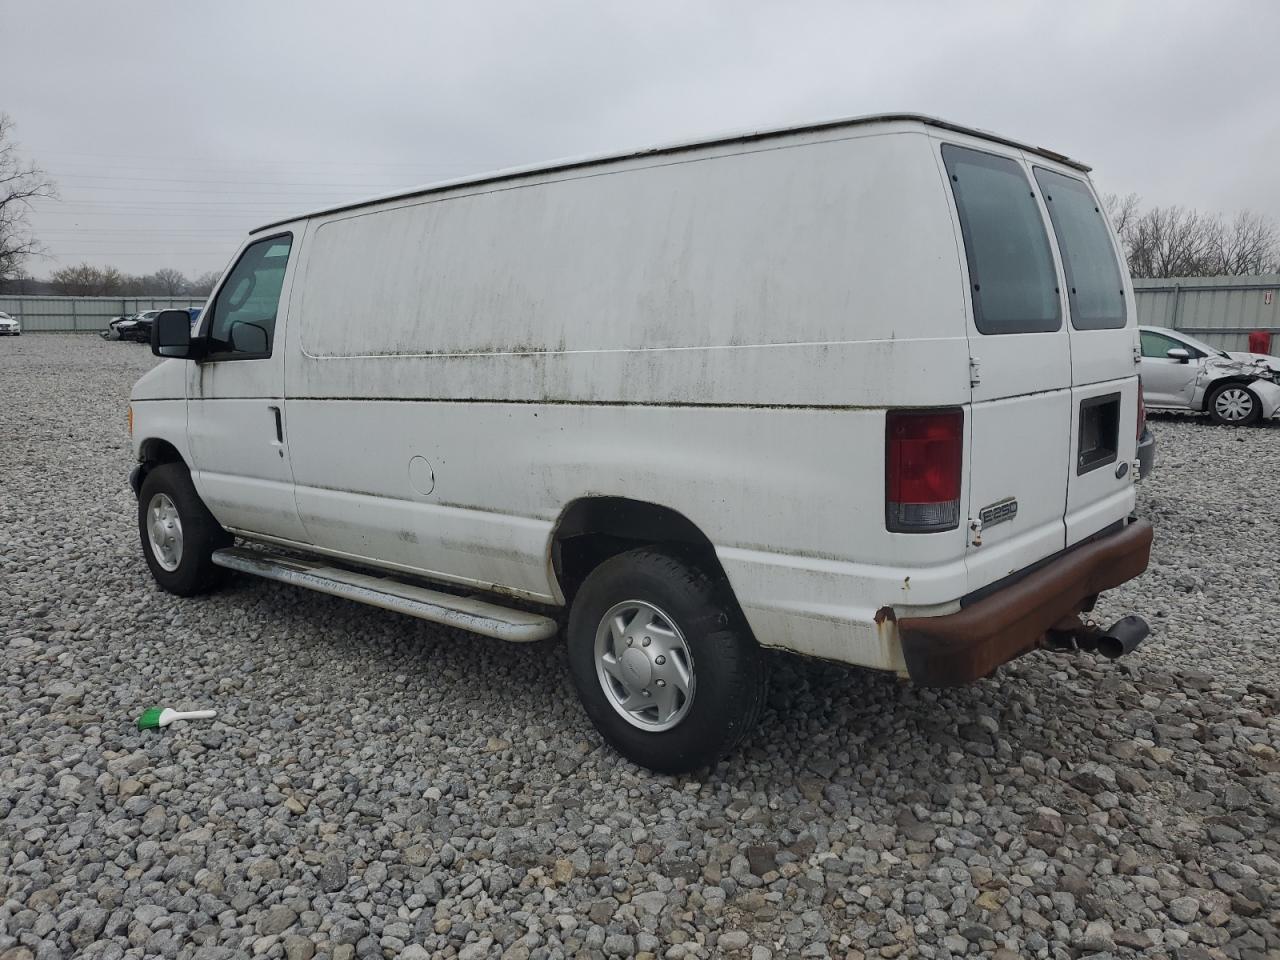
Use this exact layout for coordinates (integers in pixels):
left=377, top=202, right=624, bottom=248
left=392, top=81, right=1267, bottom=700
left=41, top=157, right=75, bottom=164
left=138, top=463, right=232, bottom=596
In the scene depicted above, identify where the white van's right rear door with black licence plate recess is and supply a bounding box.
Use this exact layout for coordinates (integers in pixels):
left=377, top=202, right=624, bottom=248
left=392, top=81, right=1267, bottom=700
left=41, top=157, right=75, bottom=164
left=1027, top=165, right=1139, bottom=544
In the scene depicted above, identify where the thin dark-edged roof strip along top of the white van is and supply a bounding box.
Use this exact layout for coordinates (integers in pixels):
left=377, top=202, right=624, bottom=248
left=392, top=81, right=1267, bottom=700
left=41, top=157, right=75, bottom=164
left=250, top=113, right=1091, bottom=234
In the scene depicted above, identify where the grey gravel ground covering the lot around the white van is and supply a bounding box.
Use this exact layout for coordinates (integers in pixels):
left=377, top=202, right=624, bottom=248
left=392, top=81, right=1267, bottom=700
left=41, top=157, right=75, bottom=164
left=0, top=334, right=1280, bottom=960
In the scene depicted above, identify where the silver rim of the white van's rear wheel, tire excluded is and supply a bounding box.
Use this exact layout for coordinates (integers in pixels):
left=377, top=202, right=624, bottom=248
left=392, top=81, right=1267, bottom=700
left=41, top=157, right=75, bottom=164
left=595, top=600, right=694, bottom=732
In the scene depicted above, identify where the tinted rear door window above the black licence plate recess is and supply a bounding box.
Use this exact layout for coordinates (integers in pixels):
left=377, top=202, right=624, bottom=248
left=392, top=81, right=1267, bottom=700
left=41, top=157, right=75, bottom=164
left=1034, top=166, right=1126, bottom=330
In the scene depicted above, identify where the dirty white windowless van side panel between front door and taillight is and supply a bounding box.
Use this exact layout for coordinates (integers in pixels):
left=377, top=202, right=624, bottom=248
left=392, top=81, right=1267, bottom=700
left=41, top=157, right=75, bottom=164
left=285, top=125, right=969, bottom=668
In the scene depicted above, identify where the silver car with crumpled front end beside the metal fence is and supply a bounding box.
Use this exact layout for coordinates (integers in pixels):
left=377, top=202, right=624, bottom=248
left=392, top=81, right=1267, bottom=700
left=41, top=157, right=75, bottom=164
left=1138, top=326, right=1280, bottom=426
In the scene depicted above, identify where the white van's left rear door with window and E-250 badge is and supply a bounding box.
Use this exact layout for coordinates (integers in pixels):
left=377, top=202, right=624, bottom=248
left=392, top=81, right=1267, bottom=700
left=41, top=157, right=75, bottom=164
left=941, top=138, right=1074, bottom=590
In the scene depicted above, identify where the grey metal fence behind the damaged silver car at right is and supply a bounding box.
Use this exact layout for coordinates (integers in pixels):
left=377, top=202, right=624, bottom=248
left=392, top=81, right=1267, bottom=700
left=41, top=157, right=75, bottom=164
left=1133, top=274, right=1280, bottom=353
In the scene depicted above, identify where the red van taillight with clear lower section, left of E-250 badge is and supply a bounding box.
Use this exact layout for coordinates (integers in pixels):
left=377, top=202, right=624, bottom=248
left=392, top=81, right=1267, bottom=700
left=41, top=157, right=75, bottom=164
left=884, top=410, right=964, bottom=534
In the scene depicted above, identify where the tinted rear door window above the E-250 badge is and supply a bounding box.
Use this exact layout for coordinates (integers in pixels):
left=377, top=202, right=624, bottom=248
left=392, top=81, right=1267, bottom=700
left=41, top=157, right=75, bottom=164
left=942, top=143, right=1062, bottom=334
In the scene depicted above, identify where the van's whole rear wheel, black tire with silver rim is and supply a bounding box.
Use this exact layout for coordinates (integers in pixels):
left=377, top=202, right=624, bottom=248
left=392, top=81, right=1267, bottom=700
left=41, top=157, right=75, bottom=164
left=568, top=548, right=767, bottom=773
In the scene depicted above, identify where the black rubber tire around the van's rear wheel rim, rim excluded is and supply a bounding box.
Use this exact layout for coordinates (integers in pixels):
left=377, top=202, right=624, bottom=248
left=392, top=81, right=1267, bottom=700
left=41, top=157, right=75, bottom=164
left=568, top=548, right=768, bottom=773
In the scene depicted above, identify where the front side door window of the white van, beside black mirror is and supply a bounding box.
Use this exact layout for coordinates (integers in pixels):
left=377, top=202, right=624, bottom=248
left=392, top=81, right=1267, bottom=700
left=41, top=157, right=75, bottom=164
left=206, top=233, right=293, bottom=360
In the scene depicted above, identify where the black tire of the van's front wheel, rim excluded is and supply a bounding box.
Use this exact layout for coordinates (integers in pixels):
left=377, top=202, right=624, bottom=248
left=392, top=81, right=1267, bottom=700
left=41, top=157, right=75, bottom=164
left=138, top=463, right=233, bottom=596
